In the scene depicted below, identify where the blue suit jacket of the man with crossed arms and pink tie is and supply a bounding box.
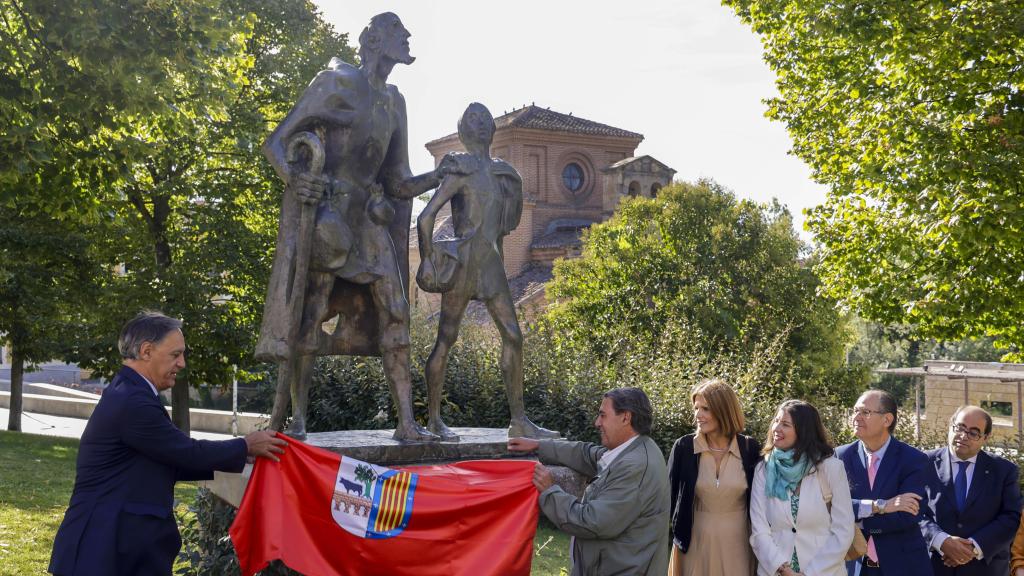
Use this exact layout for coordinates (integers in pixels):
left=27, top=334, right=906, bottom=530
left=836, top=438, right=933, bottom=576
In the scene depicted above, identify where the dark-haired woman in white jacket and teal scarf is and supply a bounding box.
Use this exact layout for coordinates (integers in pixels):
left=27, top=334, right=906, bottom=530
left=751, top=400, right=854, bottom=576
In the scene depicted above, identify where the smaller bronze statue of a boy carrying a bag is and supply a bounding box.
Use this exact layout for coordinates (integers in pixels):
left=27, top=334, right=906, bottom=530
left=416, top=102, right=558, bottom=441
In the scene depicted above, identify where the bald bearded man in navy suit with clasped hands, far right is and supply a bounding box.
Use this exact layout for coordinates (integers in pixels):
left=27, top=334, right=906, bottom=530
left=921, top=406, right=1021, bottom=576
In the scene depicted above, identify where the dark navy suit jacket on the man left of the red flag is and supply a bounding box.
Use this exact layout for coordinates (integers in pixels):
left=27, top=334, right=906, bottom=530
left=49, top=367, right=247, bottom=576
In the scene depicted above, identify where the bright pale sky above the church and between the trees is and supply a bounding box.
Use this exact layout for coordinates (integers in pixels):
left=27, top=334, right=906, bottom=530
left=315, top=0, right=825, bottom=240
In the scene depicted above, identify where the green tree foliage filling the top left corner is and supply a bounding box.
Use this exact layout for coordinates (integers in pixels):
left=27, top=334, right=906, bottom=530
left=0, top=0, right=260, bottom=426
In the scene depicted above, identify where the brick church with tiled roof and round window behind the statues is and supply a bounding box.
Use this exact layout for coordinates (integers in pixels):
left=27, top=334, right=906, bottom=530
left=410, top=106, right=676, bottom=314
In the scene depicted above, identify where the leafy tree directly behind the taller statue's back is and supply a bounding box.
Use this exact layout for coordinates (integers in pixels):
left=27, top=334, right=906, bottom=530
left=4, top=0, right=354, bottom=429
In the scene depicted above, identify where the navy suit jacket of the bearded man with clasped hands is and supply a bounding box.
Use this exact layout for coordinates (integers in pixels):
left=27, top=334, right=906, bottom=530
left=921, top=447, right=1021, bottom=576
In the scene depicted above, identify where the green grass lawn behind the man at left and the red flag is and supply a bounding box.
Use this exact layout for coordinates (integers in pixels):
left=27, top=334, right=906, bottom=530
left=0, top=430, right=568, bottom=576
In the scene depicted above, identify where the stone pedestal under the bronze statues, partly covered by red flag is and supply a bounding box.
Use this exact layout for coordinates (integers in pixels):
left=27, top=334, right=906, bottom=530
left=201, top=428, right=587, bottom=507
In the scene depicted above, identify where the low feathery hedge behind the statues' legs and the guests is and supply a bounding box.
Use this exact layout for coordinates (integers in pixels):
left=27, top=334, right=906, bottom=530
left=299, top=309, right=811, bottom=452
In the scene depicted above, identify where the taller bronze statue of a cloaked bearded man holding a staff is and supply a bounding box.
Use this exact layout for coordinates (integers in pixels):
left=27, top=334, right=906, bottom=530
left=256, top=12, right=442, bottom=441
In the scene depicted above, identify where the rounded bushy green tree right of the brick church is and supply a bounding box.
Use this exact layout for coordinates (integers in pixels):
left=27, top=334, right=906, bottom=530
left=546, top=181, right=845, bottom=393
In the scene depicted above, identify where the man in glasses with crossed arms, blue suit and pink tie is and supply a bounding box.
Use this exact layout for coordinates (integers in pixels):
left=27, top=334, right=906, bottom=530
left=836, top=389, right=932, bottom=576
